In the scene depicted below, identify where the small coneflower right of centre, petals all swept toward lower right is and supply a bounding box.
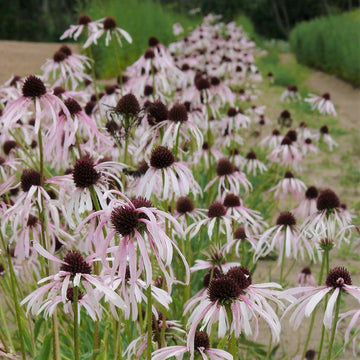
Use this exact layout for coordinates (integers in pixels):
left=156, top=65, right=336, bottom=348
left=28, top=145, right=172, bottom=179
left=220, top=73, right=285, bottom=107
left=223, top=193, right=267, bottom=234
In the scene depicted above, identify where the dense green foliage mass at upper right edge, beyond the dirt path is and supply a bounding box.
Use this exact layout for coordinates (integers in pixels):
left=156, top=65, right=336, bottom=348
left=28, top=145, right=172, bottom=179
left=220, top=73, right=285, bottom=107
left=290, top=11, right=360, bottom=86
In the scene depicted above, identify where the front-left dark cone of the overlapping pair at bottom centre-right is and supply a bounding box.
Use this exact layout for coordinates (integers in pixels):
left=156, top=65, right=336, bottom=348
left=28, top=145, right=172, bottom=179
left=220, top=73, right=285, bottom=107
left=208, top=275, right=241, bottom=305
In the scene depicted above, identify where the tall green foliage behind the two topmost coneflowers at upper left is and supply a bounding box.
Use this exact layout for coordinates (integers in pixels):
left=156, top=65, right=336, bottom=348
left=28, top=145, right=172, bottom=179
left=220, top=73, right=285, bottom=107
left=83, top=0, right=197, bottom=78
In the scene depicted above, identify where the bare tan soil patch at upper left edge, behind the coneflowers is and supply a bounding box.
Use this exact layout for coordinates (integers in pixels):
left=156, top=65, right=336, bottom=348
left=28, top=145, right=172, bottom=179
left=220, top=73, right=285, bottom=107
left=0, top=41, right=79, bottom=84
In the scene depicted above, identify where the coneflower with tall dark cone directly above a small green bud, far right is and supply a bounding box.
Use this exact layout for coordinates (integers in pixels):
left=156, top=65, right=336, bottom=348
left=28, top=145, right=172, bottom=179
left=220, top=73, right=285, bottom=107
left=301, top=189, right=351, bottom=244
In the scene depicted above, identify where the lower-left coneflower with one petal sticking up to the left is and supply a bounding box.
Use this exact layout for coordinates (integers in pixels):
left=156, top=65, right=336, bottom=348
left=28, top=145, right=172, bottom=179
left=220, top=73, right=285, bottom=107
left=21, top=246, right=125, bottom=315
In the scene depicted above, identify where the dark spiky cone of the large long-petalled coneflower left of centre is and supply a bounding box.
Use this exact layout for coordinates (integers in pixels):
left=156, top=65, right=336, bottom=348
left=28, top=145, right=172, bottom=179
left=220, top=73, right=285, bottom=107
left=110, top=206, right=139, bottom=236
